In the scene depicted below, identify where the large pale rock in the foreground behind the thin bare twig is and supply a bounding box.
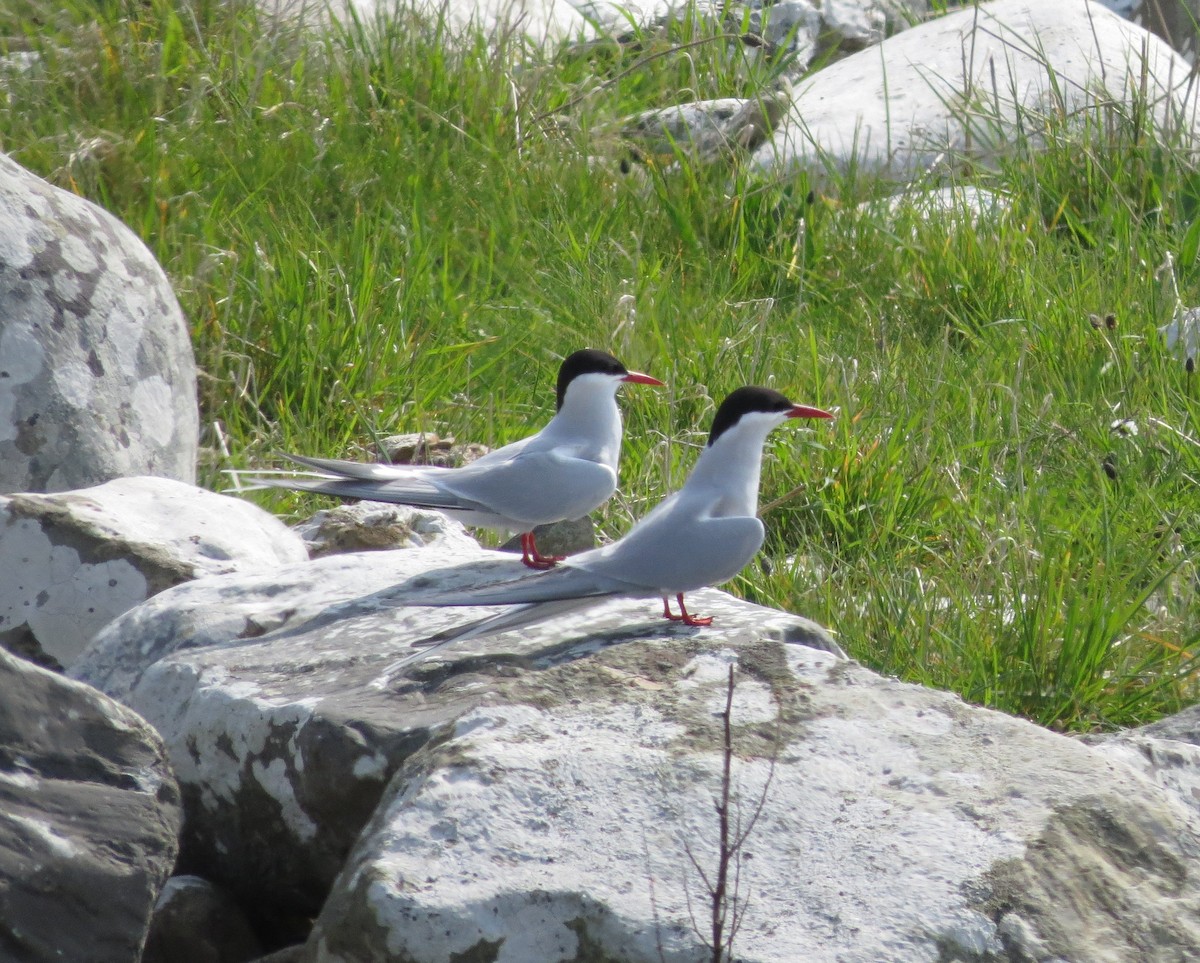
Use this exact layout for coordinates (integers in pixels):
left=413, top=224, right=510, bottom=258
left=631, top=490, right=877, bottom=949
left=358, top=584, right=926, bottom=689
left=305, top=633, right=1200, bottom=963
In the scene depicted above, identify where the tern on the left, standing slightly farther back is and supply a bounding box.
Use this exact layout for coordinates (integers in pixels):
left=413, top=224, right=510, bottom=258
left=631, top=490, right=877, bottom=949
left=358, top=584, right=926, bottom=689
left=238, top=348, right=662, bottom=561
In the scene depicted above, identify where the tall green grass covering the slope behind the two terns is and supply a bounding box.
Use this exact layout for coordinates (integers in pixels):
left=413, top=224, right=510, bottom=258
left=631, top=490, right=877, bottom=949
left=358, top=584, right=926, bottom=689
left=0, top=0, right=1200, bottom=729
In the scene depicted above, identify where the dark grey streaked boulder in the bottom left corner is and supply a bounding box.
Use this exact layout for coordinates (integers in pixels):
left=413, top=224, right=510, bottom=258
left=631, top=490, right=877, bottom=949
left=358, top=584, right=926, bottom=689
left=0, top=651, right=181, bottom=963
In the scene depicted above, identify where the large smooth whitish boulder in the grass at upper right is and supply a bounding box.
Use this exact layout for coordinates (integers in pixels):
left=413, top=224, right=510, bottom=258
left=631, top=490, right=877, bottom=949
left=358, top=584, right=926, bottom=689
left=751, top=0, right=1198, bottom=180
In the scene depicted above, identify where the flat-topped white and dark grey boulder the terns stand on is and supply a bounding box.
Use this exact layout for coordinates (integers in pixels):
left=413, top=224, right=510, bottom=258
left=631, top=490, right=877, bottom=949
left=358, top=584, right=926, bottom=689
left=71, top=544, right=835, bottom=917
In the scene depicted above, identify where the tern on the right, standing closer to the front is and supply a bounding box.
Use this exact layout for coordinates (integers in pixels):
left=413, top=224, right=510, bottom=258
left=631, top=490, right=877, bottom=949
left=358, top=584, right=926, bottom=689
left=389, top=387, right=834, bottom=671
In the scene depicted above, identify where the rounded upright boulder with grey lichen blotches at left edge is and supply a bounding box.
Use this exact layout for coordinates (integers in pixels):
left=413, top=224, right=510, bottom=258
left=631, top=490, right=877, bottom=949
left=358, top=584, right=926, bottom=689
left=0, top=155, right=199, bottom=492
